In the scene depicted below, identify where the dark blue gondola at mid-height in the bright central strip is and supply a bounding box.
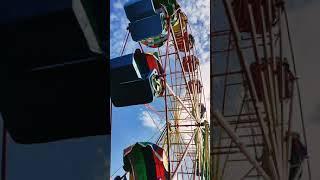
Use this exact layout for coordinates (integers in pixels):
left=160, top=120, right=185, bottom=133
left=110, top=51, right=163, bottom=107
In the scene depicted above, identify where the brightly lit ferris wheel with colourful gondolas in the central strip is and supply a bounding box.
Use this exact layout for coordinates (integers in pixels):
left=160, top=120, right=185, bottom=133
left=110, top=0, right=210, bottom=180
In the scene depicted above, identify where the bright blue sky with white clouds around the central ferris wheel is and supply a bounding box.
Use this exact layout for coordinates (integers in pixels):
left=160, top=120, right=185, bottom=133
left=110, top=0, right=210, bottom=176
